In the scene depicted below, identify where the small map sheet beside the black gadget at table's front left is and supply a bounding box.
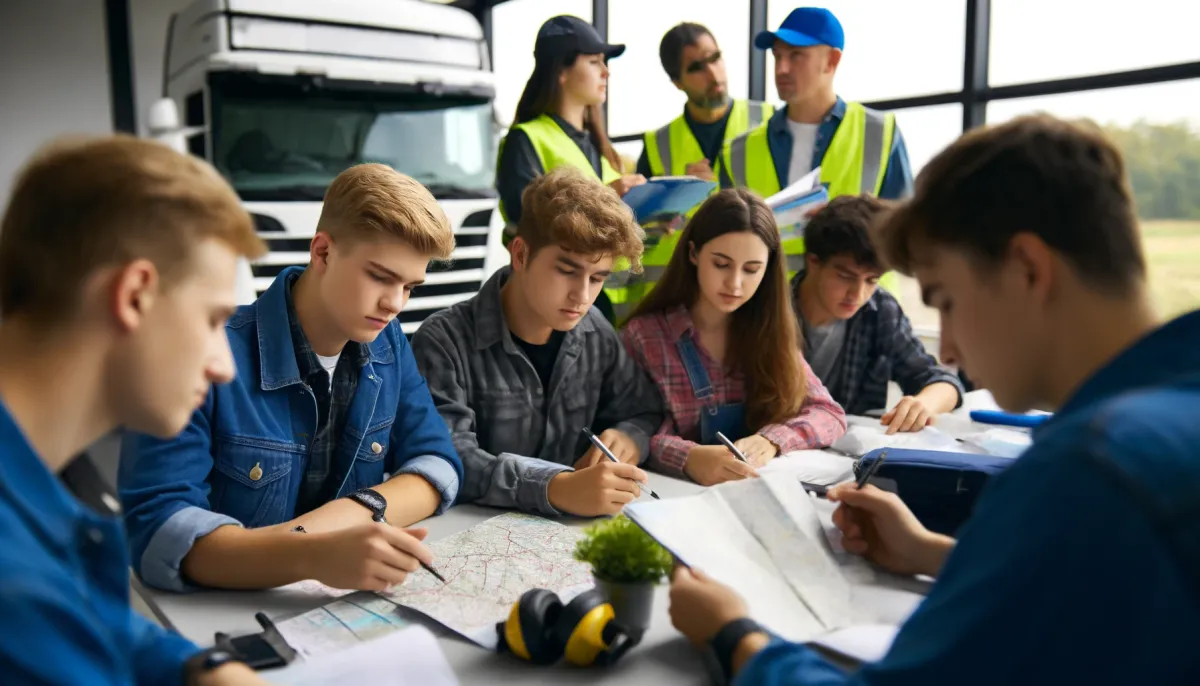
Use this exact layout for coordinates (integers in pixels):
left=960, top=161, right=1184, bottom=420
left=275, top=591, right=410, bottom=658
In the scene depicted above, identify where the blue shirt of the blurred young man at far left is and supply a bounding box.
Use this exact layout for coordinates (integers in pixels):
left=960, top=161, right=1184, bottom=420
left=0, top=404, right=199, bottom=685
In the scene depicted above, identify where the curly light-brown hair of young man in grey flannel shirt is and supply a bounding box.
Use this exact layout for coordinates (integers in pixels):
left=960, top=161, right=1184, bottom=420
left=516, top=167, right=646, bottom=273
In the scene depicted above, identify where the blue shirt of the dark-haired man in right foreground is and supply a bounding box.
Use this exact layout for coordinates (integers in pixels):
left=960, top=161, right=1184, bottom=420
left=737, top=312, right=1200, bottom=686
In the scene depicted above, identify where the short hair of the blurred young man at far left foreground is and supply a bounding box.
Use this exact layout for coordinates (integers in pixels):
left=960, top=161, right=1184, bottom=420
left=0, top=134, right=265, bottom=323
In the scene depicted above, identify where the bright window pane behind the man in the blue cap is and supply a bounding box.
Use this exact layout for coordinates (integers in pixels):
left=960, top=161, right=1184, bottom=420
left=767, top=0, right=964, bottom=104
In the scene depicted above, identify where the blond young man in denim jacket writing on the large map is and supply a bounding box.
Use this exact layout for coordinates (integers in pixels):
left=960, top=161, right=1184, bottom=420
left=120, top=164, right=462, bottom=591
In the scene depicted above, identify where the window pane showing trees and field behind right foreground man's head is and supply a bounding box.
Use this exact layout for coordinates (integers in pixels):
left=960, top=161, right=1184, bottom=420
left=988, top=79, right=1200, bottom=317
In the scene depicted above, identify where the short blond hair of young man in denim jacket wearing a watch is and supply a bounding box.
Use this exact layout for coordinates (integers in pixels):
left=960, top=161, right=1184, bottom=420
left=317, top=163, right=454, bottom=259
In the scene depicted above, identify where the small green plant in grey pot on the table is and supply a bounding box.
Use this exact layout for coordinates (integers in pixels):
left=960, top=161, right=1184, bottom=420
left=575, top=515, right=673, bottom=633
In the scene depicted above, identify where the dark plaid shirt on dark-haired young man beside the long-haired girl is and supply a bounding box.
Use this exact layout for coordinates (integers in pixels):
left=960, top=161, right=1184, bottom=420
left=792, top=270, right=962, bottom=415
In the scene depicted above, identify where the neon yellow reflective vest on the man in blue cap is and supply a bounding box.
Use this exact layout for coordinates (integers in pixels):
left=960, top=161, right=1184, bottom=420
left=724, top=102, right=895, bottom=198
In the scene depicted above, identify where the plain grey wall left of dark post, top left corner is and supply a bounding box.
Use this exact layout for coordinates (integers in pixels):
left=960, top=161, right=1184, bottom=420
left=0, top=0, right=113, bottom=207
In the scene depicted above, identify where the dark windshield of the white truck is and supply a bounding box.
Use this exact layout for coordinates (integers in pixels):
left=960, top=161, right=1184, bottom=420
left=210, top=74, right=496, bottom=200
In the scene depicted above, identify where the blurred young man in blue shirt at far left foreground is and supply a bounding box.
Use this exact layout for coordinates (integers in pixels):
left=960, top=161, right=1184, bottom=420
left=0, top=137, right=263, bottom=686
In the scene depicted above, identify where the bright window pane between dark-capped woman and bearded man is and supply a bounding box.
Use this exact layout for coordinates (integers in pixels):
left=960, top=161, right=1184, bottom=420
left=608, top=0, right=750, bottom=136
